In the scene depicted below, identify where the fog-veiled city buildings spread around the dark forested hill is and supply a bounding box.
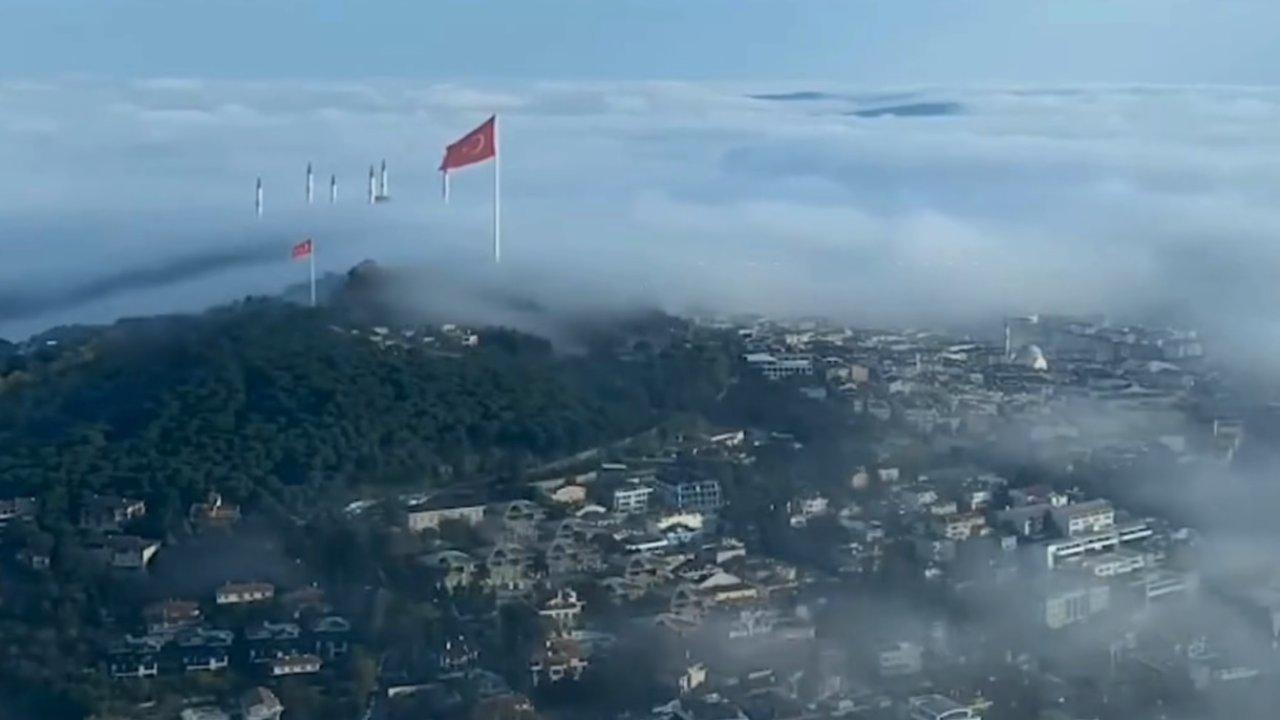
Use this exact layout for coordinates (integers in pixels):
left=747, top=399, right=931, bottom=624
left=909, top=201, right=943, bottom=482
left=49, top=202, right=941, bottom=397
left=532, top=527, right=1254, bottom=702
left=0, top=293, right=1280, bottom=720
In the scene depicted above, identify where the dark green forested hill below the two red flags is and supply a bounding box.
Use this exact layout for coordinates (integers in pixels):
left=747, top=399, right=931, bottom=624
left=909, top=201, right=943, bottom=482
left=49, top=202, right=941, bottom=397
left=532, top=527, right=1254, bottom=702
left=0, top=285, right=731, bottom=521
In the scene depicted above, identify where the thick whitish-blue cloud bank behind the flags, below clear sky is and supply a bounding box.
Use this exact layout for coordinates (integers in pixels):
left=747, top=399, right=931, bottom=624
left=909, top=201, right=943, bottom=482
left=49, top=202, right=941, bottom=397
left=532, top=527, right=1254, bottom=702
left=0, top=79, right=1280, bottom=358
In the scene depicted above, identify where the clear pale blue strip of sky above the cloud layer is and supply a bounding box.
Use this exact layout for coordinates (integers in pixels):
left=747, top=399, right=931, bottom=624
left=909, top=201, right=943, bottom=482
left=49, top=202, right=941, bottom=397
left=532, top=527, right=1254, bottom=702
left=0, top=0, right=1280, bottom=85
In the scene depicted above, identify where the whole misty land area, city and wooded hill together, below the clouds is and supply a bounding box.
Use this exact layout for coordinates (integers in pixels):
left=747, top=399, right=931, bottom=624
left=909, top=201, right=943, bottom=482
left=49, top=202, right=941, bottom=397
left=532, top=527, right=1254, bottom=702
left=0, top=293, right=1280, bottom=720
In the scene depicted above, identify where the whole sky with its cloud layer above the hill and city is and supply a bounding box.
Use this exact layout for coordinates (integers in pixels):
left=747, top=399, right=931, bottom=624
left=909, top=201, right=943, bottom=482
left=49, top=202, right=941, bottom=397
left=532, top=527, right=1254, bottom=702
left=0, top=0, right=1280, bottom=354
